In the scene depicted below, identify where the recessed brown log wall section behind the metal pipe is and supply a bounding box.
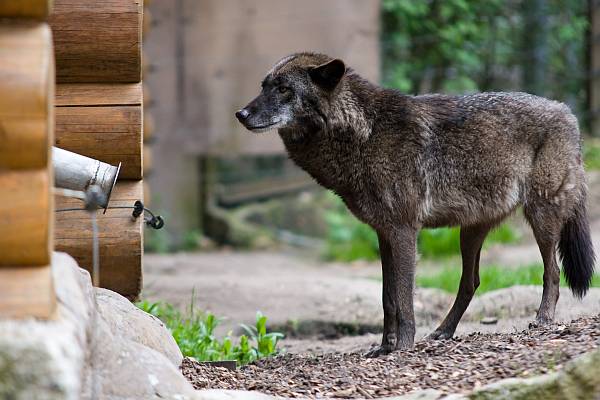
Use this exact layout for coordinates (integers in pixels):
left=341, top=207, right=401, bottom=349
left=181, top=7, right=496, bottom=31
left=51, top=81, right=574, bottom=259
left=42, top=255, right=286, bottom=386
left=49, top=0, right=144, bottom=299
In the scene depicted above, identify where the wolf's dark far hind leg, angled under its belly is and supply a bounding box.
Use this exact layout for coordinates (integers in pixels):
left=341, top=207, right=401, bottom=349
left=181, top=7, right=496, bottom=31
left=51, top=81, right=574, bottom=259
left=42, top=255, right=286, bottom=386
left=427, top=225, right=492, bottom=339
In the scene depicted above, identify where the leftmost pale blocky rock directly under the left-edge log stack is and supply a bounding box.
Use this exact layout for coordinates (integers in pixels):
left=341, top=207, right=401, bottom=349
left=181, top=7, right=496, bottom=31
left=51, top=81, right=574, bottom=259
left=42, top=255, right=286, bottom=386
left=0, top=253, right=94, bottom=400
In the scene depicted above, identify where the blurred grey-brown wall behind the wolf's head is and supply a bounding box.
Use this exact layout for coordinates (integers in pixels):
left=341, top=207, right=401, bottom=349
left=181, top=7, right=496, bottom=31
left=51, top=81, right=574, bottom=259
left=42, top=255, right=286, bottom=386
left=144, top=0, right=379, bottom=245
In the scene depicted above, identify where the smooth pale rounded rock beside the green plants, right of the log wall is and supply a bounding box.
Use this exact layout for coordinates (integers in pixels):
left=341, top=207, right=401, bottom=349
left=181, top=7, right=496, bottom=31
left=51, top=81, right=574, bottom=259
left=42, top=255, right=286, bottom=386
left=95, top=288, right=183, bottom=367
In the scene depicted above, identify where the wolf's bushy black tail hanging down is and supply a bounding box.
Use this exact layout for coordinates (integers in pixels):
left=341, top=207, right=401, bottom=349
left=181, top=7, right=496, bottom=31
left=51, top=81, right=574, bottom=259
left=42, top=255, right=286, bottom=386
left=558, top=196, right=596, bottom=298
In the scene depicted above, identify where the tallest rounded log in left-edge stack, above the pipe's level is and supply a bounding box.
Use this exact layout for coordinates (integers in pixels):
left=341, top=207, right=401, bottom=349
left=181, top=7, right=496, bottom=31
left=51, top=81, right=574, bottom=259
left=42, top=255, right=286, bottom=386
left=0, top=21, right=54, bottom=169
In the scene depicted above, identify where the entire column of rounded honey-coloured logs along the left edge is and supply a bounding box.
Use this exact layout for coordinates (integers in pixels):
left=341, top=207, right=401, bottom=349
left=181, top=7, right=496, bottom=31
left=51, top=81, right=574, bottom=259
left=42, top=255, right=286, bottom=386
left=0, top=0, right=56, bottom=318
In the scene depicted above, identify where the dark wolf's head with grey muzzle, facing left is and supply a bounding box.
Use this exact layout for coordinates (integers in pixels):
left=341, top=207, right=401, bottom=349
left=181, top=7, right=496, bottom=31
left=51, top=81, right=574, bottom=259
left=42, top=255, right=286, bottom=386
left=235, top=53, right=346, bottom=132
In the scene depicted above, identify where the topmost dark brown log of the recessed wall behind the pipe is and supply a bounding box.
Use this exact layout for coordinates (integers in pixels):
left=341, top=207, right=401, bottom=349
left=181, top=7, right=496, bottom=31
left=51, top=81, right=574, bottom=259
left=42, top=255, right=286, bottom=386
left=48, top=0, right=143, bottom=83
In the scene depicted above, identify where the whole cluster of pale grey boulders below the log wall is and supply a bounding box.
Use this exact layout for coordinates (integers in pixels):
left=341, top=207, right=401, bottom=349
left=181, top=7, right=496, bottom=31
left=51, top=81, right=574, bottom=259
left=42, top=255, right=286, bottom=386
left=0, top=253, right=196, bottom=400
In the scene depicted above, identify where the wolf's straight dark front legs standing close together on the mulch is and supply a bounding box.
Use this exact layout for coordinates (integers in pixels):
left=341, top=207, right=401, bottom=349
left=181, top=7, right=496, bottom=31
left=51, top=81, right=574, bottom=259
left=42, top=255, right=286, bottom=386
left=367, top=226, right=417, bottom=357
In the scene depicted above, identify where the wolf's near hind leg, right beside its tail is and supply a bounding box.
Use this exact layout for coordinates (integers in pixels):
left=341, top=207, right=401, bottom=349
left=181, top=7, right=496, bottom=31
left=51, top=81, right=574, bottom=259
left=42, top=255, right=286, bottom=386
left=524, top=204, right=564, bottom=324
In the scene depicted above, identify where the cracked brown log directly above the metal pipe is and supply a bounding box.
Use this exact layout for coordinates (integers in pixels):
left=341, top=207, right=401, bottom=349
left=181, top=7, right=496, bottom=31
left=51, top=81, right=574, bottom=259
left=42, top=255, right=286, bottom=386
left=55, top=83, right=143, bottom=179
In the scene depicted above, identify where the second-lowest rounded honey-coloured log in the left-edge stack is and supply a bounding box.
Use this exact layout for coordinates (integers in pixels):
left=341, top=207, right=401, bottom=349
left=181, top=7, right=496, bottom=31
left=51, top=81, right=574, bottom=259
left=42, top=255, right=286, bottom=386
left=0, top=168, right=52, bottom=268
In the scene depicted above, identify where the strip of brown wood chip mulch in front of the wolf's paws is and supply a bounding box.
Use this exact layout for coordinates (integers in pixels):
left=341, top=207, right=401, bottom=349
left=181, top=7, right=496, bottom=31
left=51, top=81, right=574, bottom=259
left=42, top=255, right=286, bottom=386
left=181, top=316, right=600, bottom=398
